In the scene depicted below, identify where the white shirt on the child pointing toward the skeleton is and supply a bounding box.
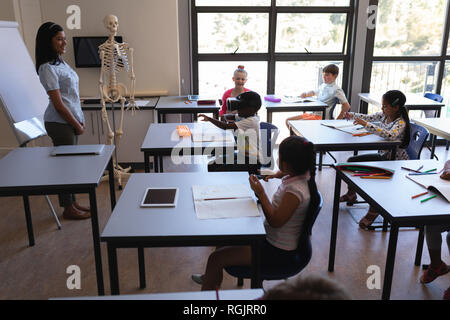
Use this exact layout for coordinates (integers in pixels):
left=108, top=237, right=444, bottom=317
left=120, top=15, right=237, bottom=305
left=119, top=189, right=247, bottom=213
left=235, top=115, right=262, bottom=161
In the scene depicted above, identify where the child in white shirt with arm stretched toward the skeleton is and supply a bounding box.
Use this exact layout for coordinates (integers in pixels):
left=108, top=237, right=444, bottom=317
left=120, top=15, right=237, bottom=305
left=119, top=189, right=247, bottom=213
left=199, top=91, right=262, bottom=174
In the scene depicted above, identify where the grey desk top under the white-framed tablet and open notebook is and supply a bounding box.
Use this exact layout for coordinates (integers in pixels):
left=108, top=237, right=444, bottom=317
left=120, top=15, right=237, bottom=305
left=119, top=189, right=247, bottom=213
left=101, top=172, right=266, bottom=244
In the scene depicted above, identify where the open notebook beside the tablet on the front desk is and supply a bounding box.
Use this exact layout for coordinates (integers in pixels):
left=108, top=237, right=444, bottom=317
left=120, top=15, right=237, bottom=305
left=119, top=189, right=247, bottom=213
left=192, top=184, right=260, bottom=219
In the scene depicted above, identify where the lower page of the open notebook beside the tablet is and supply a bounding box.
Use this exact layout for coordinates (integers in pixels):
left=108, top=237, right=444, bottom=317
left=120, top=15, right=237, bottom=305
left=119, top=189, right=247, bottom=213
left=194, top=198, right=260, bottom=219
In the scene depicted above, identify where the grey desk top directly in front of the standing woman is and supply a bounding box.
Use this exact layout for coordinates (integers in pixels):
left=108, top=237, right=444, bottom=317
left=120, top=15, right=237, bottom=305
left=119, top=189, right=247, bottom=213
left=0, top=145, right=114, bottom=191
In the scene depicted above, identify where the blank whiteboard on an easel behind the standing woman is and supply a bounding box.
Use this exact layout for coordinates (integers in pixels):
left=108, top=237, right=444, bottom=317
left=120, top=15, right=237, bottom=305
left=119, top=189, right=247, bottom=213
left=0, top=21, right=49, bottom=123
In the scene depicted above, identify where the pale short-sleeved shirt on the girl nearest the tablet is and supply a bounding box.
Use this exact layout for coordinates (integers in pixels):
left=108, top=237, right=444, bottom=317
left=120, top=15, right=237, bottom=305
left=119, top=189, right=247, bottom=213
left=264, top=173, right=310, bottom=251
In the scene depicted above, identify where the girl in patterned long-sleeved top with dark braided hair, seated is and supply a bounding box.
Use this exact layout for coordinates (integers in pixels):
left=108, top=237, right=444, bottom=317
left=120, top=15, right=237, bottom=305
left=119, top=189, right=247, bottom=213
left=339, top=90, right=411, bottom=229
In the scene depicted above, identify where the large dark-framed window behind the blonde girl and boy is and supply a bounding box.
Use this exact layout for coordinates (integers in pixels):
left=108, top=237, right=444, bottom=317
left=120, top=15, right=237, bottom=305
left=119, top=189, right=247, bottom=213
left=191, top=0, right=357, bottom=100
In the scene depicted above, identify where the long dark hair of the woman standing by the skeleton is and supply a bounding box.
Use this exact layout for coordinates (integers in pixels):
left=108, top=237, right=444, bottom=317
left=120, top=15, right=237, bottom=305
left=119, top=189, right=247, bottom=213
left=35, top=22, right=64, bottom=73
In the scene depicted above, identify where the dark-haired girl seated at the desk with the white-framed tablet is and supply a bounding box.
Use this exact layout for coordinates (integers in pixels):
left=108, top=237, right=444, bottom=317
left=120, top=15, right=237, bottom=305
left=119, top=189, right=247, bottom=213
left=192, top=136, right=317, bottom=290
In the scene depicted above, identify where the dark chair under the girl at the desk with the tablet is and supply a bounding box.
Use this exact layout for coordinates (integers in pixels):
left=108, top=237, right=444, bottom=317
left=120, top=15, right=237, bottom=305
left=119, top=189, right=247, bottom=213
left=225, top=184, right=323, bottom=286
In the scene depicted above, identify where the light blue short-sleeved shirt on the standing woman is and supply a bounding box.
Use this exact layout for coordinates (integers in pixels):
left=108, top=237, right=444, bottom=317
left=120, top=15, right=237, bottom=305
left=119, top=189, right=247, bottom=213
left=39, top=62, right=84, bottom=123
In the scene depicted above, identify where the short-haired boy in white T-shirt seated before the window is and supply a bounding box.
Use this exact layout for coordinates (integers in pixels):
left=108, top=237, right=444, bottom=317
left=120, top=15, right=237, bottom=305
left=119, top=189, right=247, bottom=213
left=286, top=64, right=350, bottom=128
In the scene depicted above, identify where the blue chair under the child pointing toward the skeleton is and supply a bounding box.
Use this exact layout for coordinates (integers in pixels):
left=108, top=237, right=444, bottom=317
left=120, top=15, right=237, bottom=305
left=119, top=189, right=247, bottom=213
left=208, top=122, right=280, bottom=174
